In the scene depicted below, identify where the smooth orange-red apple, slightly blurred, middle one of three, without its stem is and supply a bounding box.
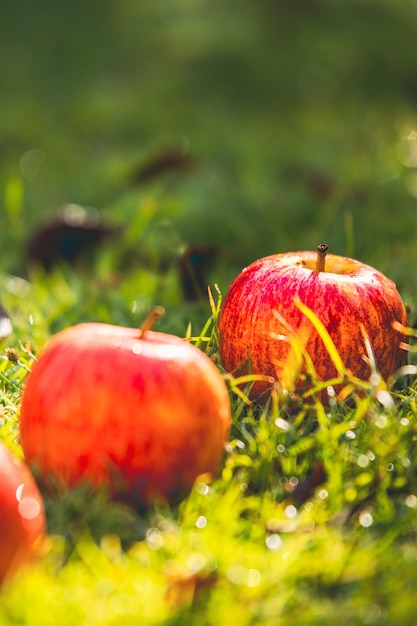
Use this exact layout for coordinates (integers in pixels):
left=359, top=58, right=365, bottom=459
left=20, top=323, right=231, bottom=508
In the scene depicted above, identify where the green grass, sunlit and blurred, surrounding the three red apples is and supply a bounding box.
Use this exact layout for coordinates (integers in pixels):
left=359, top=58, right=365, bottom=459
left=0, top=0, right=417, bottom=626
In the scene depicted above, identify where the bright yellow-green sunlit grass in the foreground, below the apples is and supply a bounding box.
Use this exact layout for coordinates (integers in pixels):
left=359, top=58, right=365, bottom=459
left=0, top=279, right=417, bottom=626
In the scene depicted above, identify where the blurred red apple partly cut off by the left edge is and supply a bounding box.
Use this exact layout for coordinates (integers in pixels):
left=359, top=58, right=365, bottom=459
left=0, top=442, right=46, bottom=584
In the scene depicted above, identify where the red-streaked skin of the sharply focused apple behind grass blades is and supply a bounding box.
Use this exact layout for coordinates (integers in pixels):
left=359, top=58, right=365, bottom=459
left=219, top=251, right=407, bottom=398
